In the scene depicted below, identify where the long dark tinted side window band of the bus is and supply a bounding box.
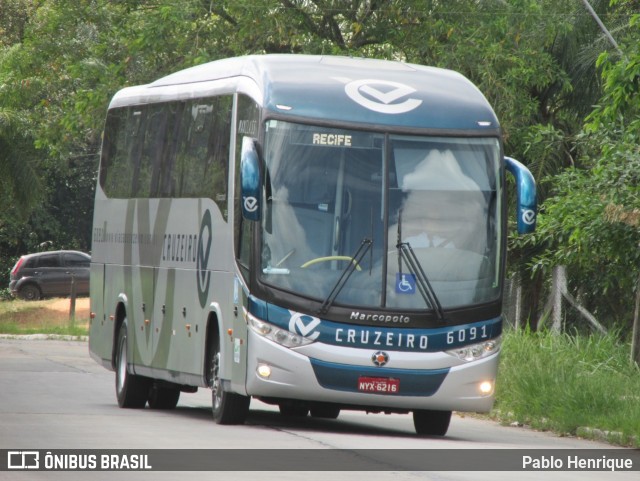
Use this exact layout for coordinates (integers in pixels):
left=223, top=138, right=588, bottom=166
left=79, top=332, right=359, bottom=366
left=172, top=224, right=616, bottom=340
left=100, top=96, right=232, bottom=204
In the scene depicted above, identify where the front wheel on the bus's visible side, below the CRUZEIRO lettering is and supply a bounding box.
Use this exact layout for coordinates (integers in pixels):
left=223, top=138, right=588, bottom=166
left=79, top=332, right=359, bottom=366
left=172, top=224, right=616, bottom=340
left=209, top=335, right=251, bottom=424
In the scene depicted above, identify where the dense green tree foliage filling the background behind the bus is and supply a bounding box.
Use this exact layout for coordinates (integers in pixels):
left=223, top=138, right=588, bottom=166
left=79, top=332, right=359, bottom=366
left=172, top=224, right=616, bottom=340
left=0, top=0, right=640, bottom=332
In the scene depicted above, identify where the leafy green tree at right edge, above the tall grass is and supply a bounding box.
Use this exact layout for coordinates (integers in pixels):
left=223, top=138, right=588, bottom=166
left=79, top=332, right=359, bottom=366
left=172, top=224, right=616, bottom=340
left=530, top=3, right=640, bottom=328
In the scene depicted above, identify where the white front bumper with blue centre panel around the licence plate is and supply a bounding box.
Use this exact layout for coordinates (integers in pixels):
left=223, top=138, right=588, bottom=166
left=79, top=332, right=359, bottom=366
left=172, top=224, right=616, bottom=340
left=246, top=330, right=499, bottom=412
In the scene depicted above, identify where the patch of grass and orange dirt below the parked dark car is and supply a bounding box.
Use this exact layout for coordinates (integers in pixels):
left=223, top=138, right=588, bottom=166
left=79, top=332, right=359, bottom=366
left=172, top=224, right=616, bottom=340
left=0, top=299, right=88, bottom=336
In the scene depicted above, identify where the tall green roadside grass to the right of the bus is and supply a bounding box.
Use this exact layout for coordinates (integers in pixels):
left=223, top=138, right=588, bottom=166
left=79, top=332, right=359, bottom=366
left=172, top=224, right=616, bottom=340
left=493, top=331, right=640, bottom=447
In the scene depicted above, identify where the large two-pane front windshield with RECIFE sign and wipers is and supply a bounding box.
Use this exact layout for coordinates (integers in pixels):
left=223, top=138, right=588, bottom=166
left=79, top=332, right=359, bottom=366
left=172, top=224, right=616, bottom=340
left=258, top=120, right=502, bottom=310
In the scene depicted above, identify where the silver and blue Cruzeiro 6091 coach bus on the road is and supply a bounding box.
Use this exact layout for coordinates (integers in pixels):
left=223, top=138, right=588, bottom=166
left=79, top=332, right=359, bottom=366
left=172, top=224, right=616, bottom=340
left=89, top=55, right=536, bottom=436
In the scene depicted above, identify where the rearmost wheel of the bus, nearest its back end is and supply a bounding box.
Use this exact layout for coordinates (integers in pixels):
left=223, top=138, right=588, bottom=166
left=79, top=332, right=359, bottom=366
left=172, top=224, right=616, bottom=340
left=116, top=320, right=150, bottom=409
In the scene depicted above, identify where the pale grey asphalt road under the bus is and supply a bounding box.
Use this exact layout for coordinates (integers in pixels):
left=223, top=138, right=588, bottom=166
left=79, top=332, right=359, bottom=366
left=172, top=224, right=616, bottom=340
left=0, top=339, right=639, bottom=481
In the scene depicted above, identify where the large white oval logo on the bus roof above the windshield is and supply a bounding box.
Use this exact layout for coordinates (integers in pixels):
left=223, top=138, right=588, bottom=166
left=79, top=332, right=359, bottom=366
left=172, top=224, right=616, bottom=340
left=344, top=79, right=422, bottom=114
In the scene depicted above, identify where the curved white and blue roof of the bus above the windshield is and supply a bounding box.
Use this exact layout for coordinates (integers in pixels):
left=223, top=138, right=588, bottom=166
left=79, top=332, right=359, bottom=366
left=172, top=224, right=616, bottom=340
left=115, top=54, right=499, bottom=135
